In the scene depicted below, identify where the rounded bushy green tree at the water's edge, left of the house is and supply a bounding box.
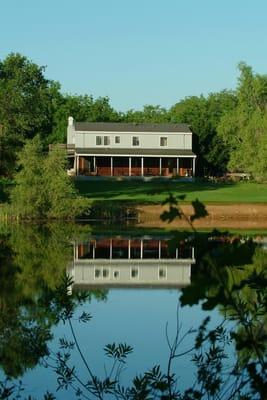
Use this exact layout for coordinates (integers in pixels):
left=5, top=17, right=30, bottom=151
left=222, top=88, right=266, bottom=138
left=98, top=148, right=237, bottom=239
left=11, top=136, right=88, bottom=219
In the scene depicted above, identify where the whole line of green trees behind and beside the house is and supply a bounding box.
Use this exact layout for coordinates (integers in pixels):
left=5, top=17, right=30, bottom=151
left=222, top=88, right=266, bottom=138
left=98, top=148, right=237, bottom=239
left=0, top=54, right=267, bottom=180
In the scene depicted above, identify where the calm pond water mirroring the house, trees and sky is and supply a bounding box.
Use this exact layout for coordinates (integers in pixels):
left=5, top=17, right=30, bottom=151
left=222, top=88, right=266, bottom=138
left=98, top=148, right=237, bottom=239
left=0, top=225, right=267, bottom=399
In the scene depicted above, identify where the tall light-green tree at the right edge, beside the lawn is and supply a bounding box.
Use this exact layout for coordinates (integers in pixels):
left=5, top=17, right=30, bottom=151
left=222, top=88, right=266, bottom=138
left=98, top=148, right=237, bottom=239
left=218, top=63, right=267, bottom=180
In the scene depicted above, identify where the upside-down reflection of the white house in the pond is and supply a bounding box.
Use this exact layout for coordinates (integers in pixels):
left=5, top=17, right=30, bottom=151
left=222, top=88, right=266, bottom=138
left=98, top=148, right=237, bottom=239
left=68, top=238, right=195, bottom=288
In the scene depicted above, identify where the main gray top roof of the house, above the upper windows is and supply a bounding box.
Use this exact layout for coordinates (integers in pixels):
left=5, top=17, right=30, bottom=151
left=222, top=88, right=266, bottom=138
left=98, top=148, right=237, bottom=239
left=75, top=122, right=191, bottom=133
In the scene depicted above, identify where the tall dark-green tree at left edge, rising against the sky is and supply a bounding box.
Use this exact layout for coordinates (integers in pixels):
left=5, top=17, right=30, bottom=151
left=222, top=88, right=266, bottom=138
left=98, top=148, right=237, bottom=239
left=0, top=53, right=58, bottom=175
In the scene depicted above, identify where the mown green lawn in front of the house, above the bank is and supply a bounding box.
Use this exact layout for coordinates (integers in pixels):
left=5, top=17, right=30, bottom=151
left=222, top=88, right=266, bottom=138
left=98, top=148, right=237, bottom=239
left=76, top=180, right=267, bottom=204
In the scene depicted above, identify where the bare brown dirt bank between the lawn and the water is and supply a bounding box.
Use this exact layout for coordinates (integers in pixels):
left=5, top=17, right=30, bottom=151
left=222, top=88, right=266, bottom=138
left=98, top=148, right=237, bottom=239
left=138, top=204, right=267, bottom=229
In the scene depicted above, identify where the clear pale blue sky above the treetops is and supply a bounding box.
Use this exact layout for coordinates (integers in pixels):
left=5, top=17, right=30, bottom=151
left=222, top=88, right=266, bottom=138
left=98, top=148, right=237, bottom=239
left=0, top=0, right=267, bottom=111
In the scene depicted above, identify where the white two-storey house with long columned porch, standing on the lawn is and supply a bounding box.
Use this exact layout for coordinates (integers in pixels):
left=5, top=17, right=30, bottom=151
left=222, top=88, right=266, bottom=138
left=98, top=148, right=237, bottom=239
left=67, top=117, right=196, bottom=177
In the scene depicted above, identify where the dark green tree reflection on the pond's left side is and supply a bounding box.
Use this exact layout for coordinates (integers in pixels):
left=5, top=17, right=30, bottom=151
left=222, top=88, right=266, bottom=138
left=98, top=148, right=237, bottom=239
left=0, top=225, right=108, bottom=378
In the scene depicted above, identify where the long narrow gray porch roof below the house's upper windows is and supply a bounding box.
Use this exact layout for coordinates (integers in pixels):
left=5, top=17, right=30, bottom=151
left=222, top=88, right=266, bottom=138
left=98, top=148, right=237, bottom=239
left=76, top=147, right=195, bottom=157
